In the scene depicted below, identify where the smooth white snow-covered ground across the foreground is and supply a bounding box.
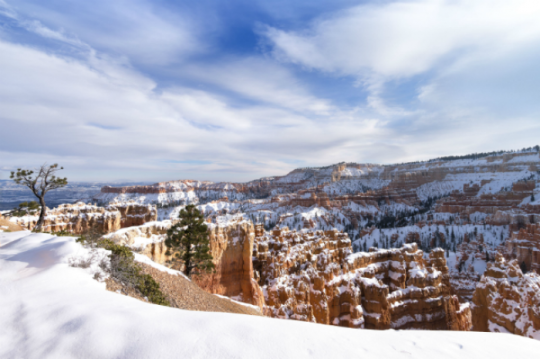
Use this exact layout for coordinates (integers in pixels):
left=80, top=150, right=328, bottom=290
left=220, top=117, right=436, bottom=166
left=0, top=231, right=540, bottom=359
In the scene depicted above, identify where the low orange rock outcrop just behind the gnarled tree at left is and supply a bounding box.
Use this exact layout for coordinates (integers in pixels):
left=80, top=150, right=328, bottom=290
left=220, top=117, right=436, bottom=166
left=10, top=202, right=157, bottom=234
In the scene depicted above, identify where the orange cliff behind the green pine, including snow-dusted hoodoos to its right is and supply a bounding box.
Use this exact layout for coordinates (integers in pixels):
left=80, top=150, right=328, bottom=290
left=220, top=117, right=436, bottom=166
left=102, top=218, right=471, bottom=330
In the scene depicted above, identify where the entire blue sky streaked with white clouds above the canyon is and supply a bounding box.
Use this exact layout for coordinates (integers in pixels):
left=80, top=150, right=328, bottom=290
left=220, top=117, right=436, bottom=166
left=0, top=0, right=540, bottom=182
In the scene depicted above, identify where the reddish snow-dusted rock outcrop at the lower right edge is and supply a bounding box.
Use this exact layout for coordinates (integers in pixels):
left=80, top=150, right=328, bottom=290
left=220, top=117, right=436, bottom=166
left=472, top=254, right=540, bottom=339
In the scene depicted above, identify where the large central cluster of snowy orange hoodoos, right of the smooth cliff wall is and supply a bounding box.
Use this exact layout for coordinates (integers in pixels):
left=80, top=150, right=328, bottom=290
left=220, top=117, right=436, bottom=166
left=253, top=227, right=471, bottom=330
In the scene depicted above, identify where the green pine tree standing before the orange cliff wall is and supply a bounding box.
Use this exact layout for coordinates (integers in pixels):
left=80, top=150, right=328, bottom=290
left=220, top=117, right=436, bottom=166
left=165, top=204, right=215, bottom=277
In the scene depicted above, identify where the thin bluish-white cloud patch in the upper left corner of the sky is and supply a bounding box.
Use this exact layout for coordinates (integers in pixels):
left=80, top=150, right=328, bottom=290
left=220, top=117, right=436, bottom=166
left=6, top=0, right=205, bottom=65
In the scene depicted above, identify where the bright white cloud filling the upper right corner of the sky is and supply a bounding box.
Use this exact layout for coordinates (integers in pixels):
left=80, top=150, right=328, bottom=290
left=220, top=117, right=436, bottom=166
left=266, top=0, right=540, bottom=78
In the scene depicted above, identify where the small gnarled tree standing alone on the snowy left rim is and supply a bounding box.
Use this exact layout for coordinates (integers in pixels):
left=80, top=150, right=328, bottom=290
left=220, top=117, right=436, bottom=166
left=10, top=163, right=67, bottom=230
